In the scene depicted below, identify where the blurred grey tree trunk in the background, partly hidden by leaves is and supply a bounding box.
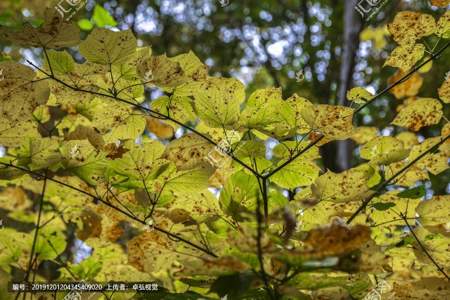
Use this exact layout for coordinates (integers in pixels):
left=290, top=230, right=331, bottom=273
left=336, top=0, right=362, bottom=171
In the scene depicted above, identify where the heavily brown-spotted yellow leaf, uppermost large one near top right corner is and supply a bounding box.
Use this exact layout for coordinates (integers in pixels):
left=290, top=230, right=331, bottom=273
left=388, top=11, right=436, bottom=45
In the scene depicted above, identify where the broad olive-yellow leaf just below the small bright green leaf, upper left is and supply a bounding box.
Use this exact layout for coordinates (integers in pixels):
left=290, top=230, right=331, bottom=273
left=80, top=28, right=136, bottom=65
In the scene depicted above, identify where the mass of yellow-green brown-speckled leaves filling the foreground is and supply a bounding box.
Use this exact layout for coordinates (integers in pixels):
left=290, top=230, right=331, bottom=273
left=0, top=3, right=450, bottom=299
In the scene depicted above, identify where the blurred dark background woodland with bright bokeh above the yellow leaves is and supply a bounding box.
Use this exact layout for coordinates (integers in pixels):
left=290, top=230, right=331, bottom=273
left=0, top=0, right=450, bottom=185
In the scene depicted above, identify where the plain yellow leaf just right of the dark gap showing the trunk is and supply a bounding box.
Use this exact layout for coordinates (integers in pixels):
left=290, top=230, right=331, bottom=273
left=361, top=136, right=408, bottom=165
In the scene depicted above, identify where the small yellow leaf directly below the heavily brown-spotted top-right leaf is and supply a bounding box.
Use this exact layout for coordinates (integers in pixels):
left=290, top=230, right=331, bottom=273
left=384, top=44, right=425, bottom=72
